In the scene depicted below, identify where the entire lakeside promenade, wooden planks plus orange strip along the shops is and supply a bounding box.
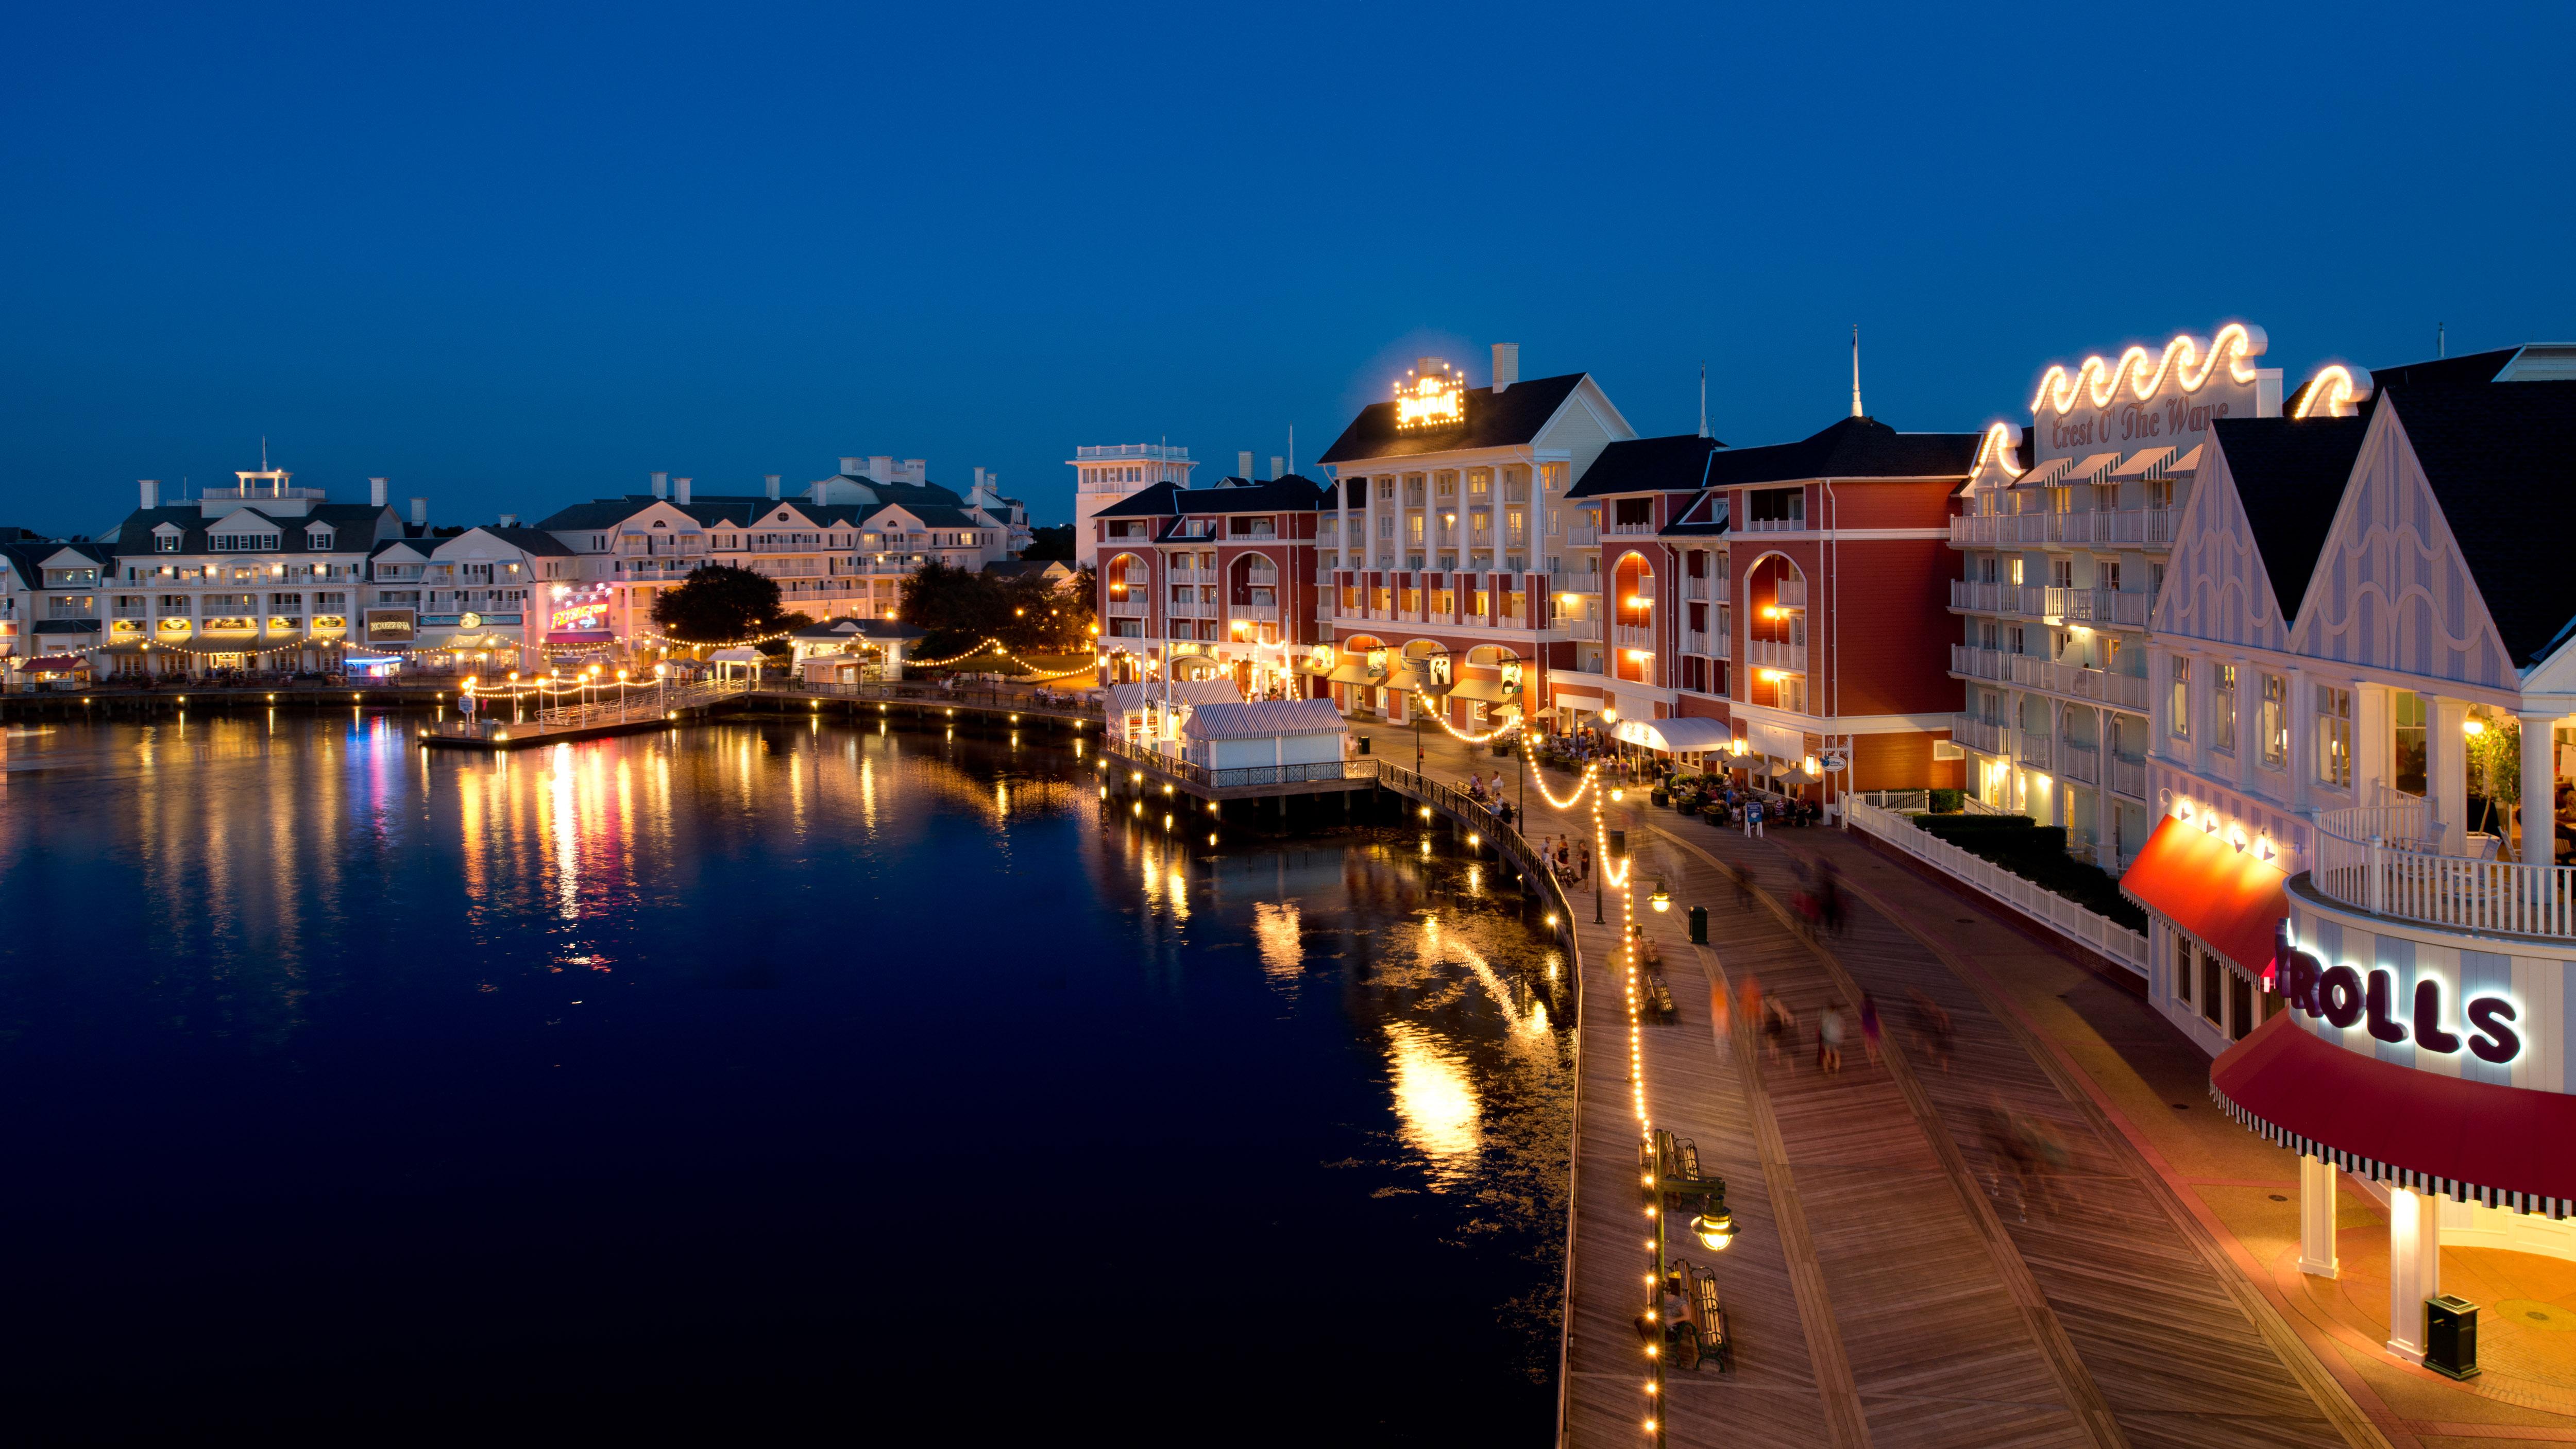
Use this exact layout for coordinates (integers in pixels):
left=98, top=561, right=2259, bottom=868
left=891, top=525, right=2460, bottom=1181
left=1381, top=739, right=2576, bottom=1449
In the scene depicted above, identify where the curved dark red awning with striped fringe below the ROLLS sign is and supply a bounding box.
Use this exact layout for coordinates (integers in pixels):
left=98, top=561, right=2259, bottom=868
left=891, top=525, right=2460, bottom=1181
left=2210, top=1012, right=2576, bottom=1217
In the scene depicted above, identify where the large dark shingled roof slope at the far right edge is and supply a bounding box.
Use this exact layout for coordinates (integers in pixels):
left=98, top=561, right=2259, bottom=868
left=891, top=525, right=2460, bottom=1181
left=2378, top=381, right=2576, bottom=664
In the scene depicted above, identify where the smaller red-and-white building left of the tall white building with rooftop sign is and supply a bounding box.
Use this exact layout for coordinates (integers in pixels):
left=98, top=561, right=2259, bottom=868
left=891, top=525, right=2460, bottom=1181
left=1092, top=473, right=1329, bottom=697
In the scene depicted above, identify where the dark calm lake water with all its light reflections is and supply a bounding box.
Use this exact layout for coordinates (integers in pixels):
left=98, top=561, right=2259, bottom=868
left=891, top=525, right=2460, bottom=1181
left=0, top=713, right=1571, bottom=1446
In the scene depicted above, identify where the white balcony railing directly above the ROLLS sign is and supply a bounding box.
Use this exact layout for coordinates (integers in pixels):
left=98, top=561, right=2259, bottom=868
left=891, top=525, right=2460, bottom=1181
left=2308, top=806, right=2576, bottom=940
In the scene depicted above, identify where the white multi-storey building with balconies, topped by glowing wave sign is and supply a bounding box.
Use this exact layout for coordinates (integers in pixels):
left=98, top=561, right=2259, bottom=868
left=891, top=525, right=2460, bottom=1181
left=1947, top=322, right=2280, bottom=870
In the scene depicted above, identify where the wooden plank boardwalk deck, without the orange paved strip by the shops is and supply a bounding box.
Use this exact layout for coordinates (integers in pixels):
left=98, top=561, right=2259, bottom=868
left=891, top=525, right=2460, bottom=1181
left=1461, top=741, right=2385, bottom=1446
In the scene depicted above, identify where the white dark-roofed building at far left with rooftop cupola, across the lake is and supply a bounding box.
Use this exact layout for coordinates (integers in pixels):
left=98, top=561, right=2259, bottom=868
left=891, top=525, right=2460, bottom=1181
left=94, top=466, right=430, bottom=677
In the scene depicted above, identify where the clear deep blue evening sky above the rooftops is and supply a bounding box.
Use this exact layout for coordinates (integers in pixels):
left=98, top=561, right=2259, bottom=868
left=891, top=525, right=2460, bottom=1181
left=0, top=5, right=2576, bottom=533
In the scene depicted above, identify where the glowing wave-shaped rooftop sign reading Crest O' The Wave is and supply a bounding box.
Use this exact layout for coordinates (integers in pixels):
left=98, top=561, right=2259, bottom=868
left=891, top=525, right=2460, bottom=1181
left=2030, top=322, right=2280, bottom=466
